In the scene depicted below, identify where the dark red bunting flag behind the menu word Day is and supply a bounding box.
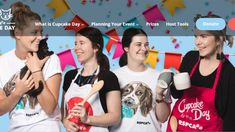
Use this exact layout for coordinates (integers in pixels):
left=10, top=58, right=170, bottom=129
left=65, top=15, right=89, bottom=32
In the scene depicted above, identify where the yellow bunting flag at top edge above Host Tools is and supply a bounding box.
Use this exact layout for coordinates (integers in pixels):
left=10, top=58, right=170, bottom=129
left=163, top=0, right=186, bottom=16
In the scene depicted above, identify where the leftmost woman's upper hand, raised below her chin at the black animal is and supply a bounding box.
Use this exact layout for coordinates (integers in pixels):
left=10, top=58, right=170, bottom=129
left=26, top=52, right=49, bottom=72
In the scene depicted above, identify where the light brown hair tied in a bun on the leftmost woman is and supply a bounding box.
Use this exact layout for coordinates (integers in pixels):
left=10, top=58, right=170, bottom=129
left=10, top=2, right=41, bottom=37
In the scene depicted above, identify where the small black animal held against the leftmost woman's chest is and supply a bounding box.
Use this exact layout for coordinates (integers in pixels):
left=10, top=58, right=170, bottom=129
left=20, top=38, right=54, bottom=97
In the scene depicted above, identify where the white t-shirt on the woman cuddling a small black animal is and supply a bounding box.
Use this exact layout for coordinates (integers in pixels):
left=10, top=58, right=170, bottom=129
left=0, top=49, right=61, bottom=129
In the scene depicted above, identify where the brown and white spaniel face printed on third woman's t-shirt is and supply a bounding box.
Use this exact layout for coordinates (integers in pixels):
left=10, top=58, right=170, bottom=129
left=122, top=82, right=152, bottom=116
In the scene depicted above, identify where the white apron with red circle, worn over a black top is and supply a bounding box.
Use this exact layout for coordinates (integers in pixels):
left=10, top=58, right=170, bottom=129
left=64, top=68, right=108, bottom=132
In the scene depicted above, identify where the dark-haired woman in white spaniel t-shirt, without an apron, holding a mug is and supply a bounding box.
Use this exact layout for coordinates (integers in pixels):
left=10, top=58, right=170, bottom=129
left=111, top=28, right=170, bottom=132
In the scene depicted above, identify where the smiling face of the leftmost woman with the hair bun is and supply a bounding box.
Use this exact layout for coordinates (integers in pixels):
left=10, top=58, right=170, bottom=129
left=16, top=20, right=42, bottom=52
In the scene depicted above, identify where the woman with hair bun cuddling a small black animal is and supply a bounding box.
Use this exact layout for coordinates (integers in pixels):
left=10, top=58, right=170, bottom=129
left=0, top=2, right=61, bottom=132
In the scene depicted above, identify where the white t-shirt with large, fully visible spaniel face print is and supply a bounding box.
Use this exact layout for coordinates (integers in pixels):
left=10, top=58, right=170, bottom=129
left=110, top=66, right=161, bottom=132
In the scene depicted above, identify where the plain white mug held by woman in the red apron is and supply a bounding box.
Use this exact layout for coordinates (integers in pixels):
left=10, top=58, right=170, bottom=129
left=173, top=72, right=191, bottom=90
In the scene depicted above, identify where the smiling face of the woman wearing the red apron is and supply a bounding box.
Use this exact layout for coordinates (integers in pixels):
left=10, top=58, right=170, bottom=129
left=195, top=30, right=222, bottom=57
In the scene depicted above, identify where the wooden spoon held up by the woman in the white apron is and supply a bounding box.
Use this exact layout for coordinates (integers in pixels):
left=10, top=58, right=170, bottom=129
left=80, top=80, right=104, bottom=105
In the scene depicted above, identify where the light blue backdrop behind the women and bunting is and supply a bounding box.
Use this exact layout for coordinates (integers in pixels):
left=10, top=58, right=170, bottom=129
left=0, top=0, right=235, bottom=132
